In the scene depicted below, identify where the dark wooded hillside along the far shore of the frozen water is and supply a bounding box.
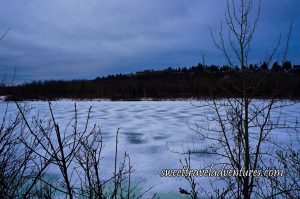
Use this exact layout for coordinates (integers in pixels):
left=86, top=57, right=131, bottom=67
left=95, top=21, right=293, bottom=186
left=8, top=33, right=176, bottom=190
left=0, top=61, right=300, bottom=100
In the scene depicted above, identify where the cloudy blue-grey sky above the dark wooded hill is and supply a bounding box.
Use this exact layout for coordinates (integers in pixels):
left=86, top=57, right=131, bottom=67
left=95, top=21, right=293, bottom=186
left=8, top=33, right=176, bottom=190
left=0, top=0, right=300, bottom=82
